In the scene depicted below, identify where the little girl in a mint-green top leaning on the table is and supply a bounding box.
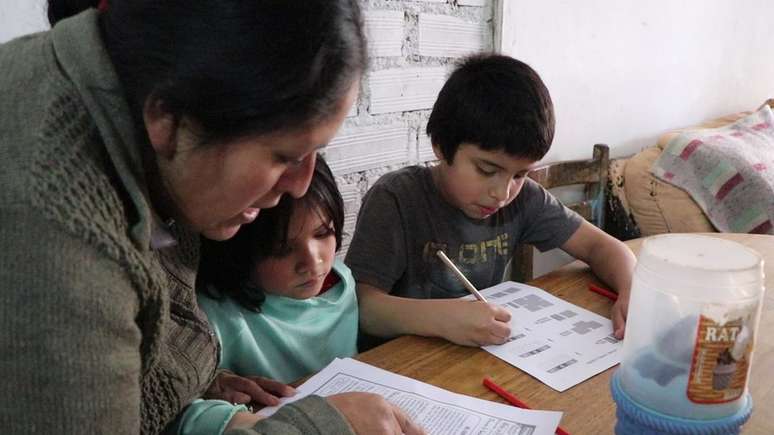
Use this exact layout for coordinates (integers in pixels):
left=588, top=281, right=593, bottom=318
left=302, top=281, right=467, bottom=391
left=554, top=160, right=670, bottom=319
left=181, top=156, right=358, bottom=433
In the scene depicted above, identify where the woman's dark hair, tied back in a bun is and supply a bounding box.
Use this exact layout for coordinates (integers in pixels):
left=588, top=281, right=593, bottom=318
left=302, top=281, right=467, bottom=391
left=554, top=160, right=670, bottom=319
left=48, top=0, right=367, bottom=142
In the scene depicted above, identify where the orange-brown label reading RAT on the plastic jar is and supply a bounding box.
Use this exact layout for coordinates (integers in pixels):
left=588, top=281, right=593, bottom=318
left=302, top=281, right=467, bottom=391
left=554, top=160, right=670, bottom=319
left=686, top=303, right=758, bottom=404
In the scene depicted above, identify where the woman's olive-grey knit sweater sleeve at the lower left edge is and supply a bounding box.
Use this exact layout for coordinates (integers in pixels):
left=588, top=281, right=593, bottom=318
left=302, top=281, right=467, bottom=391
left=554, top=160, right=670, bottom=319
left=0, top=205, right=141, bottom=434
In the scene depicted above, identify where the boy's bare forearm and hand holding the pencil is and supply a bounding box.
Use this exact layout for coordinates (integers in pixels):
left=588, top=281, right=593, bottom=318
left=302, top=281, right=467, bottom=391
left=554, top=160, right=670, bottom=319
left=357, top=282, right=511, bottom=346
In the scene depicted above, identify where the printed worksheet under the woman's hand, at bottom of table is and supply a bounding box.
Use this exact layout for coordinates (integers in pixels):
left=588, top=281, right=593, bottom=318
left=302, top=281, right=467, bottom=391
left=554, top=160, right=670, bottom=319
left=259, top=358, right=562, bottom=435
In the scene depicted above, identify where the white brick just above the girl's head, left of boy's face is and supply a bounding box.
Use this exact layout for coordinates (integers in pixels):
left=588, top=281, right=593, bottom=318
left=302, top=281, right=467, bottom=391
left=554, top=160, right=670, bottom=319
left=325, top=124, right=411, bottom=175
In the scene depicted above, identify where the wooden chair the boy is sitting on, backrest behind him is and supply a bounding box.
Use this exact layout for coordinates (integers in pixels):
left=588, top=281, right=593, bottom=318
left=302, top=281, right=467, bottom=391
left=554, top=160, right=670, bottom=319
left=511, top=144, right=610, bottom=282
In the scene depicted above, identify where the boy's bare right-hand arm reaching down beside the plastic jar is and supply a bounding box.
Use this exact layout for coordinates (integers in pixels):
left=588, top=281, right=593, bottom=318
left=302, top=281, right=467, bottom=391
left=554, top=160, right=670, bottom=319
left=562, top=221, right=637, bottom=339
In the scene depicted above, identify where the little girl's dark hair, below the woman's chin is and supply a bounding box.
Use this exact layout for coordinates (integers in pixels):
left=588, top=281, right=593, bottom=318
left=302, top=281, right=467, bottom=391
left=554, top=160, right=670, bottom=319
left=197, top=156, right=344, bottom=311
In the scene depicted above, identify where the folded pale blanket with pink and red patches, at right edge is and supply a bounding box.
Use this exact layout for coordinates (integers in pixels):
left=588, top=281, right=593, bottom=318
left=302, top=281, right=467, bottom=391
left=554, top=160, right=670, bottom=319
left=651, top=105, right=774, bottom=234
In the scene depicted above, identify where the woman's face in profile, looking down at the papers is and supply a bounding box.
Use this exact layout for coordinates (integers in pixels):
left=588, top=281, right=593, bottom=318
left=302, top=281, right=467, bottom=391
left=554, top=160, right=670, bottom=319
left=153, top=81, right=358, bottom=240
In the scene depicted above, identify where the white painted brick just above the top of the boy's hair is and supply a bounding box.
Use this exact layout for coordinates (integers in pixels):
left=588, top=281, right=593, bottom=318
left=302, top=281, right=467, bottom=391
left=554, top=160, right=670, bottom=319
left=419, top=14, right=487, bottom=57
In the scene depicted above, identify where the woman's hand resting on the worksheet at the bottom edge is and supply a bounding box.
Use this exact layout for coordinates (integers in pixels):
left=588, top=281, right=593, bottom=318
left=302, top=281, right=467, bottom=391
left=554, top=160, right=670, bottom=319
left=326, top=393, right=426, bottom=435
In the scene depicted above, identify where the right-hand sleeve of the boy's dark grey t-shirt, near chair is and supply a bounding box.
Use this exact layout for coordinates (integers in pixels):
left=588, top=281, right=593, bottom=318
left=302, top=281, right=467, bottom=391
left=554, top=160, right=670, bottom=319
left=519, top=180, right=583, bottom=252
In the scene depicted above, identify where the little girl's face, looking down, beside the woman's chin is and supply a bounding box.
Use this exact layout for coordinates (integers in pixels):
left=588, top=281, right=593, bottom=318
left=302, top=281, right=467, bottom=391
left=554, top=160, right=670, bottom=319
left=251, top=206, right=336, bottom=299
